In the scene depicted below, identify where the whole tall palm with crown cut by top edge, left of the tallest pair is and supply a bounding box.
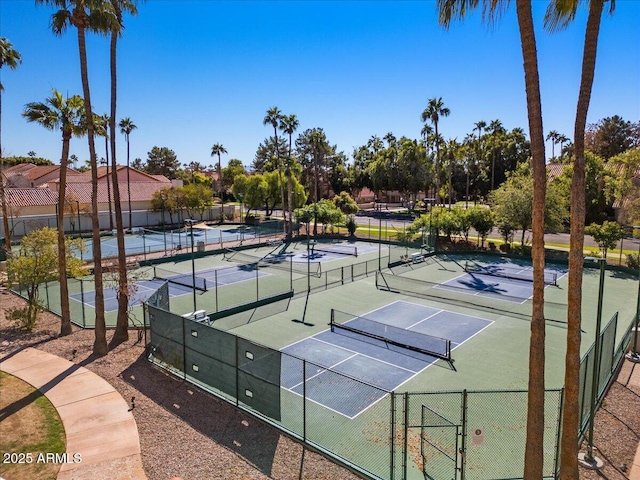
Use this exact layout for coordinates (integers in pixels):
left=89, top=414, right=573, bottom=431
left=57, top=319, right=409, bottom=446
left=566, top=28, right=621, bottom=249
left=36, top=0, right=115, bottom=357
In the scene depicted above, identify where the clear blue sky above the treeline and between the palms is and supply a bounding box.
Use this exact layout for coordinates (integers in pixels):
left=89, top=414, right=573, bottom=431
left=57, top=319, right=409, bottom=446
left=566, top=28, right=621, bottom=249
left=0, top=0, right=640, bottom=171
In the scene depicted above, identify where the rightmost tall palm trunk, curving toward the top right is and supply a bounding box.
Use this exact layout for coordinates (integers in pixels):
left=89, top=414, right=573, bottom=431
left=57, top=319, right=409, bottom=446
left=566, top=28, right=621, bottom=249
left=560, top=0, right=603, bottom=480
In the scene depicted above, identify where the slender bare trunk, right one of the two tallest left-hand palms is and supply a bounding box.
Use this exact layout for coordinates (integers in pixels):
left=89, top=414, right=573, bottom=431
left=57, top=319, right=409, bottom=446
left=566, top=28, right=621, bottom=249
left=107, top=15, right=129, bottom=345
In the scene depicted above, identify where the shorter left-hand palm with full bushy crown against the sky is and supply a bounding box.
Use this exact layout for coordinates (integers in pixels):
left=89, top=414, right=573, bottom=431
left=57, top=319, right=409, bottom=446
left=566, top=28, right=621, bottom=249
left=22, top=89, right=86, bottom=335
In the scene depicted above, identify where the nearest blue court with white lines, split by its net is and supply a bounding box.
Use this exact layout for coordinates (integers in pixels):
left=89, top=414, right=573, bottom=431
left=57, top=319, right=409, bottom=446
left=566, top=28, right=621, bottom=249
left=281, top=301, right=492, bottom=418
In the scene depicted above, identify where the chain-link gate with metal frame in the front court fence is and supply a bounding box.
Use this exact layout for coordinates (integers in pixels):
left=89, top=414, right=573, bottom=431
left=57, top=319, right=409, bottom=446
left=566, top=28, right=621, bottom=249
left=420, top=404, right=461, bottom=480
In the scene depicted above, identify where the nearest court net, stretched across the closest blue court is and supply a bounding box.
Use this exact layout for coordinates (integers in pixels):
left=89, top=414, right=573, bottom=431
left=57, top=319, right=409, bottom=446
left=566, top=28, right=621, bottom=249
left=330, top=308, right=451, bottom=361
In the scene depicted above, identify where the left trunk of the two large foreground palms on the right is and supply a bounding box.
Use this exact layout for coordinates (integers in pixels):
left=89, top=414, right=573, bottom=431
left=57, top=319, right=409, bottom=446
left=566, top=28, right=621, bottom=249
left=516, top=0, right=546, bottom=480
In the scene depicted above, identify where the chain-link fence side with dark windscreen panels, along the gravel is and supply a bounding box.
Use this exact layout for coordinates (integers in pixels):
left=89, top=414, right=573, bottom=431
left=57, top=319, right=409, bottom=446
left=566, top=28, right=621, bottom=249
left=147, top=288, right=391, bottom=478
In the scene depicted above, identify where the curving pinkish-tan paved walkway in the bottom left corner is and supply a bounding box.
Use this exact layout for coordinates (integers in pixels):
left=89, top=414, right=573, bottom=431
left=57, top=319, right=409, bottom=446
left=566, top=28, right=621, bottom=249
left=0, top=348, right=147, bottom=480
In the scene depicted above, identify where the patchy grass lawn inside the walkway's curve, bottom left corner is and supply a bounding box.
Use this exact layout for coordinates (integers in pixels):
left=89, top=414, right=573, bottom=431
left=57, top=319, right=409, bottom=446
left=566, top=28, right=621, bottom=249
left=0, top=372, right=66, bottom=480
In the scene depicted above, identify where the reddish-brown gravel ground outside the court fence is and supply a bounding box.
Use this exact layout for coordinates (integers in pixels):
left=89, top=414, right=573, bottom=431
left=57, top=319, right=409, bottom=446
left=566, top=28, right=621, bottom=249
left=0, top=287, right=640, bottom=480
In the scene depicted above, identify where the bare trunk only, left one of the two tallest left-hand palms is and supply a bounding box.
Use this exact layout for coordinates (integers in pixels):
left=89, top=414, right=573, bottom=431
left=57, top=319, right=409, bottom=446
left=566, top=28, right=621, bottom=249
left=76, top=22, right=109, bottom=357
